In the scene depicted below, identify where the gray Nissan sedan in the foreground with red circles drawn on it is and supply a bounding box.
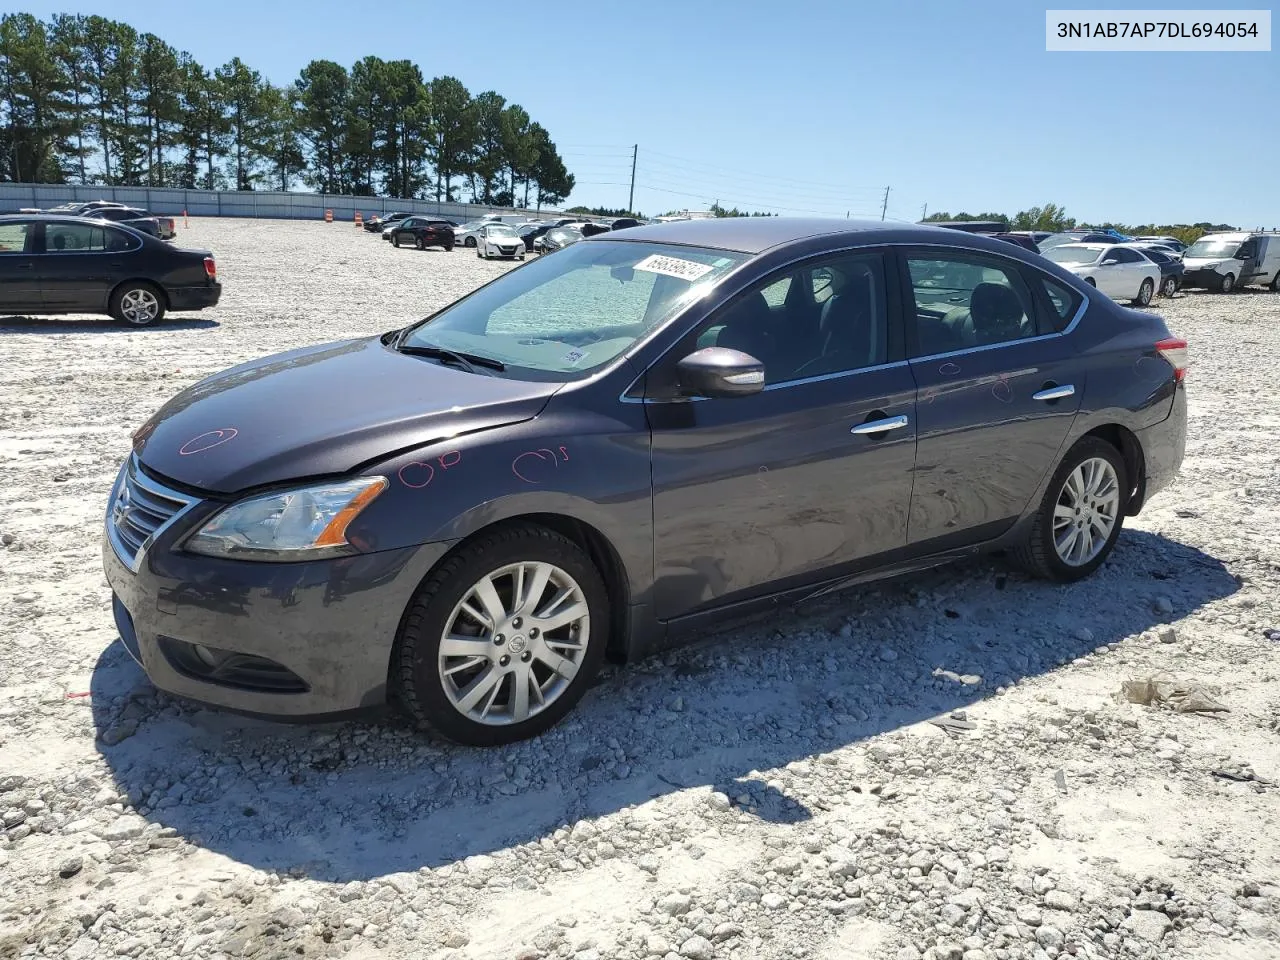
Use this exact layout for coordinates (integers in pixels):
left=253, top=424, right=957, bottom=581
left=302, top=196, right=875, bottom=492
left=104, top=218, right=1187, bottom=744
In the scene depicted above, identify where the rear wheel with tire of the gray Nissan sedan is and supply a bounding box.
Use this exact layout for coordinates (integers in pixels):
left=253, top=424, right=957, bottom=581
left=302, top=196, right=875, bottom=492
left=1014, top=436, right=1129, bottom=584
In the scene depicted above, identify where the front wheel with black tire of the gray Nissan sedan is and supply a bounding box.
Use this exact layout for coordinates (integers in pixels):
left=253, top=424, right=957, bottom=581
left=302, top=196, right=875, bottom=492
left=392, top=525, right=609, bottom=746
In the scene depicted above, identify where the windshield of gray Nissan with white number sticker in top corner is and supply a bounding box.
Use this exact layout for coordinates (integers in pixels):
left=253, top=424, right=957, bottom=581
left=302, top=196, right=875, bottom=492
left=401, top=241, right=748, bottom=380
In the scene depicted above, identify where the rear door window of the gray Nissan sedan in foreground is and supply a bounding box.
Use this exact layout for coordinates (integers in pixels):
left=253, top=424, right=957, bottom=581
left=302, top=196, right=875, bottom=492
left=908, top=255, right=1037, bottom=356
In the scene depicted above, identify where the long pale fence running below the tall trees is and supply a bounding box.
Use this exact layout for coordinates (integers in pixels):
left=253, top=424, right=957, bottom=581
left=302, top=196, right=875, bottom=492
left=0, top=183, right=556, bottom=221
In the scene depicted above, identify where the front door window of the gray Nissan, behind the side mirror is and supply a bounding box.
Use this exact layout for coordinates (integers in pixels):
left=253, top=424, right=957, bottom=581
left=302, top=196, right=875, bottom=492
left=691, top=253, right=888, bottom=384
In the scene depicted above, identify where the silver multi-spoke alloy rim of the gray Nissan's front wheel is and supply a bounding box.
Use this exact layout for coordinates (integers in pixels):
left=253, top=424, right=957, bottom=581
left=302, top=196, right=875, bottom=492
left=439, top=561, right=591, bottom=726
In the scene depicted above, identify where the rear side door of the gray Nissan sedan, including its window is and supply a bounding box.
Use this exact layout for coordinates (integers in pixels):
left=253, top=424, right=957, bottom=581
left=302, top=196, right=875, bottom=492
left=905, top=250, right=1084, bottom=552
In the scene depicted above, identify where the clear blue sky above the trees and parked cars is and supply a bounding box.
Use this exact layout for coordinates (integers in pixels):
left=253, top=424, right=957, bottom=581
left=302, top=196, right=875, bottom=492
left=17, top=0, right=1280, bottom=227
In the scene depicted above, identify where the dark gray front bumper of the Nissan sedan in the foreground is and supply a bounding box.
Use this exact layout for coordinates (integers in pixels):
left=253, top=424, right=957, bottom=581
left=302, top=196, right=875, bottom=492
left=102, top=504, right=451, bottom=719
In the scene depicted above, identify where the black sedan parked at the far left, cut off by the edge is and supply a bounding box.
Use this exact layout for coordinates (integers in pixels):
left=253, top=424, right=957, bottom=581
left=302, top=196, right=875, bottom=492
left=0, top=215, right=223, bottom=326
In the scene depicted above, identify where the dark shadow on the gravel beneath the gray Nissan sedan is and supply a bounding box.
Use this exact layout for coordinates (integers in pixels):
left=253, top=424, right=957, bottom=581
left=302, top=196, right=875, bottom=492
left=91, top=531, right=1239, bottom=881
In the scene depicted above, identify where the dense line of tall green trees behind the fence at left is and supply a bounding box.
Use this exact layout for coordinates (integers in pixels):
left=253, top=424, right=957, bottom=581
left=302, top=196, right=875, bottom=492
left=0, top=13, right=573, bottom=206
